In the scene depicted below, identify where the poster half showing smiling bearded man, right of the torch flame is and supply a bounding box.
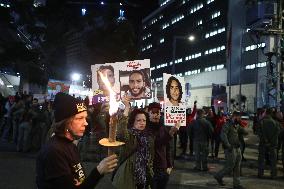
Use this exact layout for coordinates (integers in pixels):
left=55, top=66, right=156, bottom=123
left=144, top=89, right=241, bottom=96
left=119, top=59, right=152, bottom=100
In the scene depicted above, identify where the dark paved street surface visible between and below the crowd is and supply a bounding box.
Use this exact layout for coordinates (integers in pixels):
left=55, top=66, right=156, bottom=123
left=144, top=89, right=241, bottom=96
left=0, top=126, right=284, bottom=189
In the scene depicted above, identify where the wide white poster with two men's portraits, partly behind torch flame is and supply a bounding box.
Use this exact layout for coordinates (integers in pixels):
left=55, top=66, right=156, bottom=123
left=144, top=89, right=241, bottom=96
left=91, top=59, right=151, bottom=103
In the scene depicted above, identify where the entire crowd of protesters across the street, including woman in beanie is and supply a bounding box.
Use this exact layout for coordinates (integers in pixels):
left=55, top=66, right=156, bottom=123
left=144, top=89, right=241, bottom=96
left=0, top=93, right=284, bottom=189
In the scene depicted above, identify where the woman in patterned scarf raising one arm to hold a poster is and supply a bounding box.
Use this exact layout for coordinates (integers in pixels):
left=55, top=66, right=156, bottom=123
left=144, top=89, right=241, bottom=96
left=113, top=97, right=154, bottom=189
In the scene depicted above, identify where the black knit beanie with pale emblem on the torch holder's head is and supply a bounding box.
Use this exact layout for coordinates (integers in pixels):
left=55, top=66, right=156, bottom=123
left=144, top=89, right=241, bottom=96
left=54, top=92, right=87, bottom=122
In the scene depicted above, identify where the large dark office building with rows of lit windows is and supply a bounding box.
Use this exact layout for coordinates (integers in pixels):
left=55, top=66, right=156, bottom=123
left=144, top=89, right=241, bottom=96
left=140, top=0, right=278, bottom=110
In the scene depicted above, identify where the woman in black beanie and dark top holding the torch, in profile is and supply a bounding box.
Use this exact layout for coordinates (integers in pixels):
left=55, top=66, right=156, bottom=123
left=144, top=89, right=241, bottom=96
left=36, top=92, right=117, bottom=189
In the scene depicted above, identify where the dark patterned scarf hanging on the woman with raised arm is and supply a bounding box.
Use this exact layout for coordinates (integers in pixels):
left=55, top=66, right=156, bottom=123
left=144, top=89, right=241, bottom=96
left=130, top=128, right=150, bottom=185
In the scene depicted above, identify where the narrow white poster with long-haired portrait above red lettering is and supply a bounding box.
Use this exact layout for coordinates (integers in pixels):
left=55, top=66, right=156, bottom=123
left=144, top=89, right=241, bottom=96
left=163, top=73, right=186, bottom=126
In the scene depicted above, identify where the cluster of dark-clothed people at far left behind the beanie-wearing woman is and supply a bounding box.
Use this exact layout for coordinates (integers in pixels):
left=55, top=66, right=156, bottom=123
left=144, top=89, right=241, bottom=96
left=0, top=93, right=53, bottom=152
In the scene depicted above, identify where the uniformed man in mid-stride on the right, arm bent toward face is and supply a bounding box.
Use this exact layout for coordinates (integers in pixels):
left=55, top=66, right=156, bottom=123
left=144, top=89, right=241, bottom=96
left=214, top=111, right=247, bottom=189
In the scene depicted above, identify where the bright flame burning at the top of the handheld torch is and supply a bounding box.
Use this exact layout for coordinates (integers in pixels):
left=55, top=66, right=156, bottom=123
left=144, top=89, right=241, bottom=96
left=98, top=71, right=119, bottom=116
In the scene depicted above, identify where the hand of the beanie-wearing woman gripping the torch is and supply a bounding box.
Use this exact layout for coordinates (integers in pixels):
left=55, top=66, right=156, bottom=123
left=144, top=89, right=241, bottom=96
left=97, top=154, right=118, bottom=175
